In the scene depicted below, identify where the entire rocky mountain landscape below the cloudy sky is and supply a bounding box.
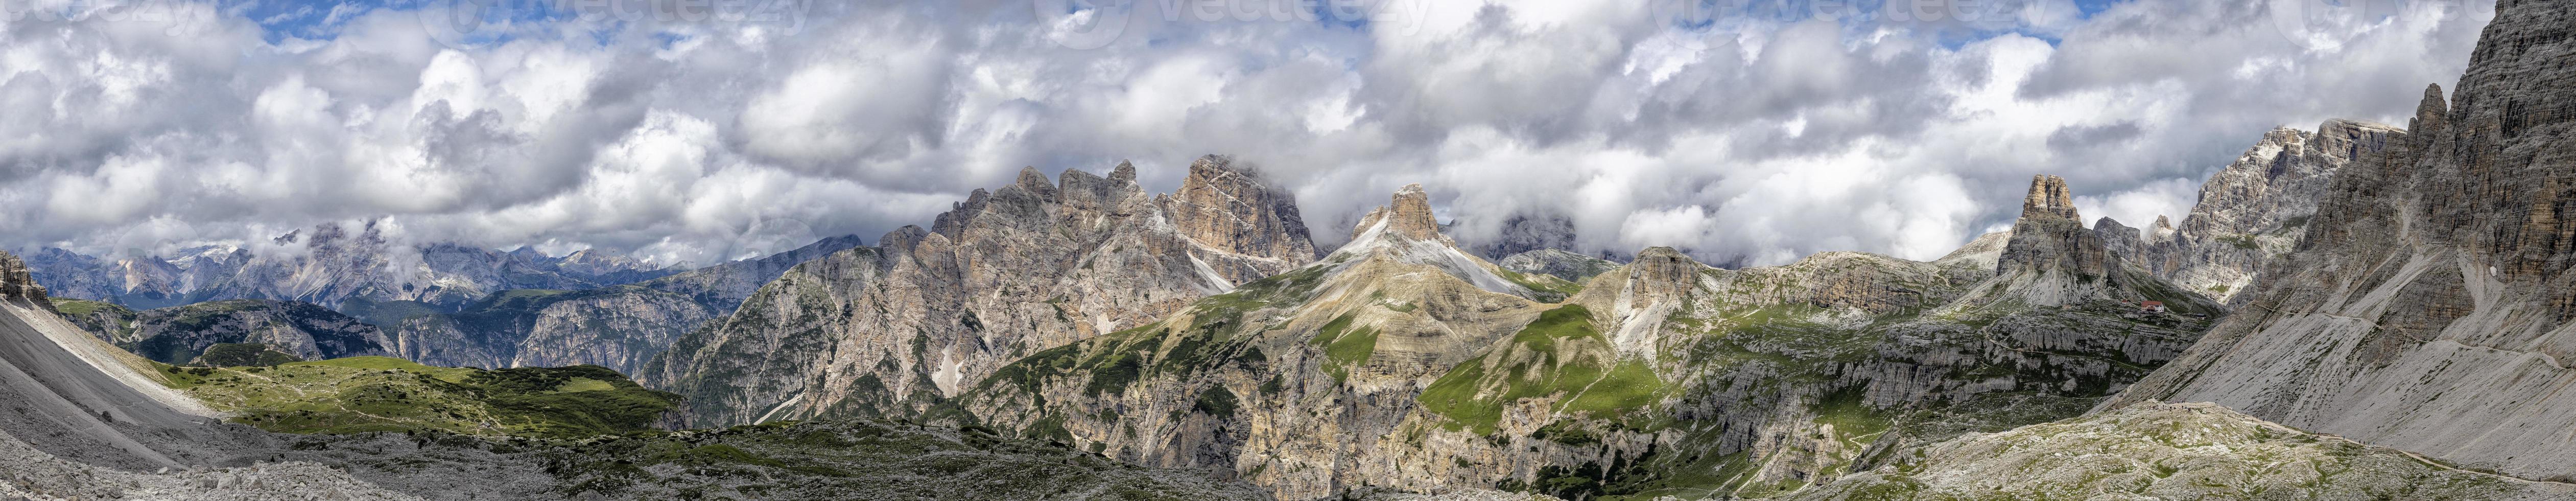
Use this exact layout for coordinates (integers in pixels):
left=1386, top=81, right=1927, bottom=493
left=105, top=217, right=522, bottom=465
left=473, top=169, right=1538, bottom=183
left=0, top=0, right=2576, bottom=501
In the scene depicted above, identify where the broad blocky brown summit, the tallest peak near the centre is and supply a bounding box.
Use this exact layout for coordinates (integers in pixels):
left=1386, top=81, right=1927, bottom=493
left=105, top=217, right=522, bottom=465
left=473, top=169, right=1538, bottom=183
left=1174, top=155, right=1314, bottom=263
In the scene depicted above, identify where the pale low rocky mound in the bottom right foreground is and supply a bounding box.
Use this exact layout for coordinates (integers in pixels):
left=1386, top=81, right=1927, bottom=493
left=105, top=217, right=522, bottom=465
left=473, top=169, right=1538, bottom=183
left=1788, top=403, right=2576, bottom=501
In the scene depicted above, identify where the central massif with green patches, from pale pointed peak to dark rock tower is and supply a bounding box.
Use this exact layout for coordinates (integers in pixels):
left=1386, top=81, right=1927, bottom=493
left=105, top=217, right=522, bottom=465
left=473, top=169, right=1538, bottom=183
left=930, top=184, right=2218, bottom=498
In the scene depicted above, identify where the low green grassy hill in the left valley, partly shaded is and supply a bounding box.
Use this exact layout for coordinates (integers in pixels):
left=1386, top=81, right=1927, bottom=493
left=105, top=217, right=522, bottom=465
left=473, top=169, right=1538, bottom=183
left=162, top=356, right=680, bottom=437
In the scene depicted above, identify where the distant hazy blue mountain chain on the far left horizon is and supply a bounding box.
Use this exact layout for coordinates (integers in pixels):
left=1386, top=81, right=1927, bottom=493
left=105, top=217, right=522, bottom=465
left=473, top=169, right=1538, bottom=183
left=34, top=222, right=677, bottom=310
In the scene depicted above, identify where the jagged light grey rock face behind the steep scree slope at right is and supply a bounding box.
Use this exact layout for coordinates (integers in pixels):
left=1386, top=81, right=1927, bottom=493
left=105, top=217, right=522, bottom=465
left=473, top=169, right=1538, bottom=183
left=2112, top=119, right=2406, bottom=302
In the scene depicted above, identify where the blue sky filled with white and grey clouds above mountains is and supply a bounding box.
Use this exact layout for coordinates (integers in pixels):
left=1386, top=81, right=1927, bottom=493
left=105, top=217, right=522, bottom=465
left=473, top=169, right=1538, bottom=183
left=0, top=0, right=2494, bottom=266
